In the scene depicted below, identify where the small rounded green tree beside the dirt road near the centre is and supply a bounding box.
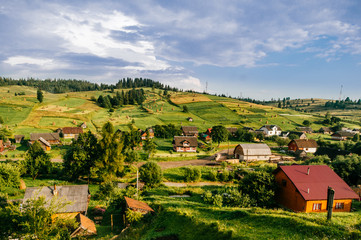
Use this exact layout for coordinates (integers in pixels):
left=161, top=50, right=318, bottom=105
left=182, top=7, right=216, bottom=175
left=139, top=162, right=163, bottom=187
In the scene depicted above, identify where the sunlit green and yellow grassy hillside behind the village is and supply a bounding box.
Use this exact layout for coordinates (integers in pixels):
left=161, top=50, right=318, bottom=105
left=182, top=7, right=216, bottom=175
left=0, top=86, right=361, bottom=141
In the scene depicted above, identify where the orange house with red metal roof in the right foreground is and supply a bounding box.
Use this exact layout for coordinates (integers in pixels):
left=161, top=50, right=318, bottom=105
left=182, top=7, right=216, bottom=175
left=274, top=165, right=359, bottom=212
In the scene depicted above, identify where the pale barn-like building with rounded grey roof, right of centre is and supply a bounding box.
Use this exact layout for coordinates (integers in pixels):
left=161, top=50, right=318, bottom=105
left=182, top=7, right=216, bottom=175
left=233, top=143, right=272, bottom=161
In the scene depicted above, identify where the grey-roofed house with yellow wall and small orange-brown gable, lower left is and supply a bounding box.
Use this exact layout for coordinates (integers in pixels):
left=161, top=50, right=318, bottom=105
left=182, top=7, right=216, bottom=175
left=23, top=185, right=96, bottom=237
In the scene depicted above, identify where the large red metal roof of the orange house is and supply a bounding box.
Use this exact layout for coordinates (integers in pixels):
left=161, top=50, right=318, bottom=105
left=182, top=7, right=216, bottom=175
left=280, top=165, right=359, bottom=201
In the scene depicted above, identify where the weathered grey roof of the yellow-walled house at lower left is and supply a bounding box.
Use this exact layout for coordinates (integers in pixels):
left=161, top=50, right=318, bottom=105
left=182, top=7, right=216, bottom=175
left=23, top=185, right=90, bottom=212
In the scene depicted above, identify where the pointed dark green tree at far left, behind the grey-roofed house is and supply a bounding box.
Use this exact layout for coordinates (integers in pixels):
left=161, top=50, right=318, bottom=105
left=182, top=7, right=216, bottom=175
left=24, top=141, right=52, bottom=180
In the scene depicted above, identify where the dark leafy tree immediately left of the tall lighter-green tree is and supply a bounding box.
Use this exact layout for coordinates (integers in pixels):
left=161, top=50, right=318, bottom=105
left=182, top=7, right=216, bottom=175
left=63, top=132, right=100, bottom=180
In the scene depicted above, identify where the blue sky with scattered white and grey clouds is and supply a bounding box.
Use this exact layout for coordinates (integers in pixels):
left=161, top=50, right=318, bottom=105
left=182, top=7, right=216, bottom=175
left=0, top=0, right=361, bottom=100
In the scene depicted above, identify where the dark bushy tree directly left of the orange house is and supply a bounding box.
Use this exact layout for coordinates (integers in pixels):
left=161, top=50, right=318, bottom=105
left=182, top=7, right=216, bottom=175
left=239, top=172, right=276, bottom=207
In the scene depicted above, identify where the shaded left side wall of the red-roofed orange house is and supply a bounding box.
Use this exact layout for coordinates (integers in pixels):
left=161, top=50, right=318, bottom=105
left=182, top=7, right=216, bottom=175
left=275, top=171, right=306, bottom=212
